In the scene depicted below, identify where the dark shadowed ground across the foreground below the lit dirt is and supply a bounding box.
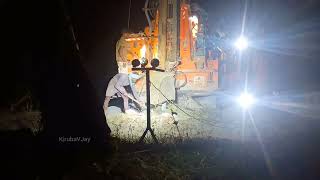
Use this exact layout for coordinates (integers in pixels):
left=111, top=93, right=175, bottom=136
left=1, top=127, right=320, bottom=180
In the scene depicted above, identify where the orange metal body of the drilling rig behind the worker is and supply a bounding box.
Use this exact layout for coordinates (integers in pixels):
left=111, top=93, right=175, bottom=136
left=116, top=1, right=219, bottom=91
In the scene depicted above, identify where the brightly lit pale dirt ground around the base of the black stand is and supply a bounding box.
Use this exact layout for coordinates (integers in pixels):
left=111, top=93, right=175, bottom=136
left=106, top=96, right=241, bottom=142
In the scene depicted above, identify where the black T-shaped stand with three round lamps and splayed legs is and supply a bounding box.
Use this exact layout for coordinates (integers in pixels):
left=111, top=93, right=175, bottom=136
left=132, top=58, right=164, bottom=143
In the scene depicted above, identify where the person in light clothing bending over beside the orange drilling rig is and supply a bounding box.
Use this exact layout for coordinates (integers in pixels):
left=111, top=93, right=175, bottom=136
left=103, top=73, right=143, bottom=113
